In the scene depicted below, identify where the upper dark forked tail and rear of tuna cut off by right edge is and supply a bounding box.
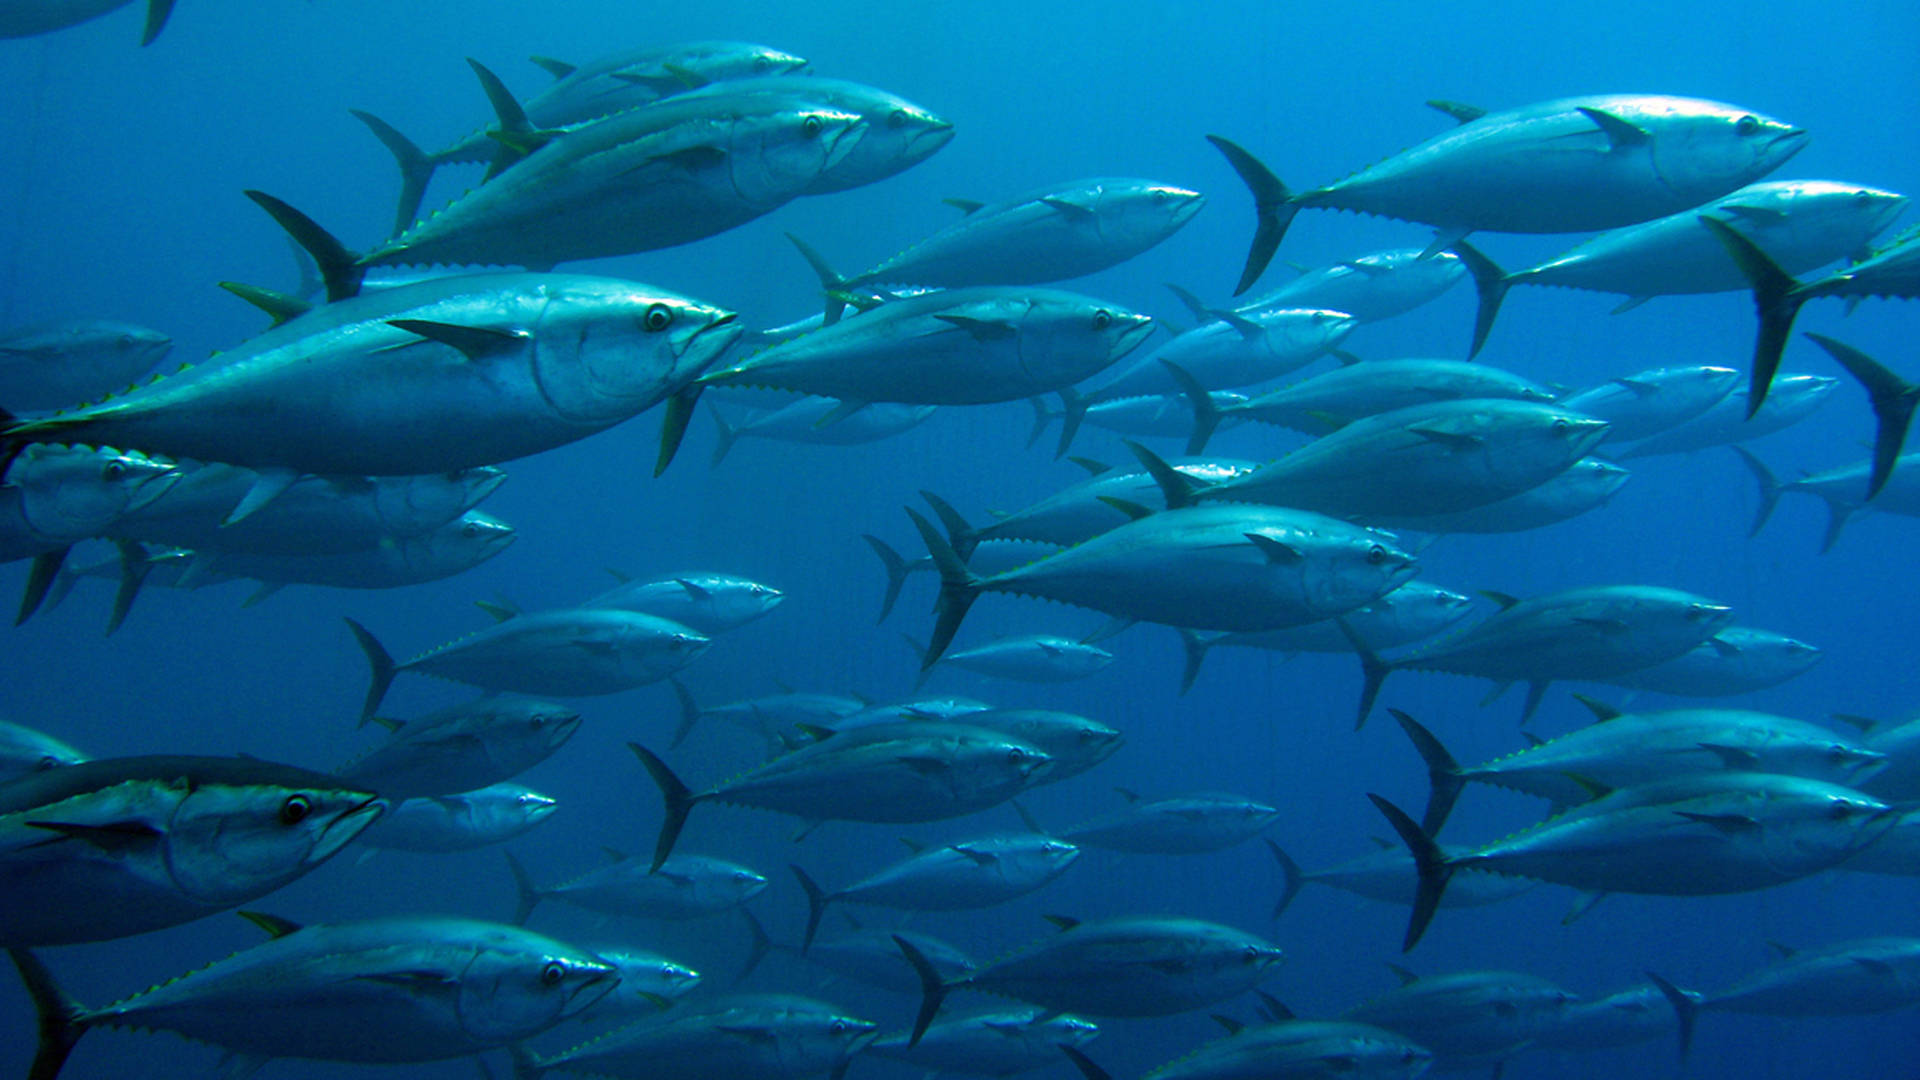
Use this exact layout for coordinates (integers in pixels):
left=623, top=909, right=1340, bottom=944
left=1701, top=217, right=1920, bottom=415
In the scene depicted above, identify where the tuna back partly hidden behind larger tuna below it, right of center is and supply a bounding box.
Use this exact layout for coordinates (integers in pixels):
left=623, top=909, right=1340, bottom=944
left=1221, top=359, right=1566, bottom=434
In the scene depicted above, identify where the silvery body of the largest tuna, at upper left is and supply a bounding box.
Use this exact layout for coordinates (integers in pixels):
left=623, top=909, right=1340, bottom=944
left=0, top=275, right=739, bottom=477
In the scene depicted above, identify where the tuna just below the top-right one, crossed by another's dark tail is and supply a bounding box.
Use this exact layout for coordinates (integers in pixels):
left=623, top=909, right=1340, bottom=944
left=1453, top=181, right=1907, bottom=356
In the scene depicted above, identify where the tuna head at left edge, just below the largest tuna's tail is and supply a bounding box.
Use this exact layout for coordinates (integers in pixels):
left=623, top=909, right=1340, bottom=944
left=6, top=444, right=182, bottom=540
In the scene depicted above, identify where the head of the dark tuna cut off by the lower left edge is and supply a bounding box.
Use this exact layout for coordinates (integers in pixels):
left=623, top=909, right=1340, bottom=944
left=163, top=763, right=388, bottom=907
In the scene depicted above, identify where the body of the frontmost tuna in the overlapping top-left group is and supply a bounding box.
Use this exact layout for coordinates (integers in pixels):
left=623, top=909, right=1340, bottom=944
left=359, top=94, right=868, bottom=267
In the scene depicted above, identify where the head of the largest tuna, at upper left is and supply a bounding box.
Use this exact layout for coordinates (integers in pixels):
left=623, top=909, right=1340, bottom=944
left=534, top=277, right=743, bottom=427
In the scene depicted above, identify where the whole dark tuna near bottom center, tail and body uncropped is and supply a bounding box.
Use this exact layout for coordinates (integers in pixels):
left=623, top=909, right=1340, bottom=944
left=895, top=917, right=1283, bottom=1047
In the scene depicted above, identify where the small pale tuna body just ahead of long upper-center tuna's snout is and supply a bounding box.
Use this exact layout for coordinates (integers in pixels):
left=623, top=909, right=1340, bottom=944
left=1092, top=307, right=1359, bottom=400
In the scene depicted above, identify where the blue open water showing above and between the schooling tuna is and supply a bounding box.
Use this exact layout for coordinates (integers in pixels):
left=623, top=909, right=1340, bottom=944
left=0, top=0, right=1920, bottom=1078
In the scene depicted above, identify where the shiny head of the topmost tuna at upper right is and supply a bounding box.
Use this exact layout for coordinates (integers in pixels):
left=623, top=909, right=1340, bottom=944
left=1622, top=98, right=1807, bottom=206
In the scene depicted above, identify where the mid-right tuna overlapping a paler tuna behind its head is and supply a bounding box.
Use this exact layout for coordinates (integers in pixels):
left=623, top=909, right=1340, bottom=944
left=1356, top=584, right=1734, bottom=726
